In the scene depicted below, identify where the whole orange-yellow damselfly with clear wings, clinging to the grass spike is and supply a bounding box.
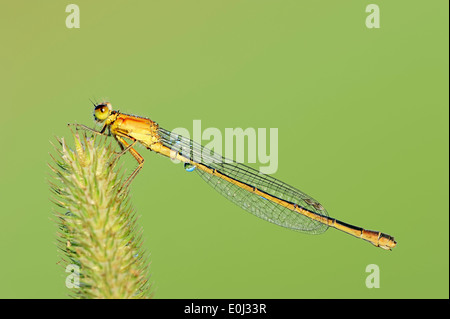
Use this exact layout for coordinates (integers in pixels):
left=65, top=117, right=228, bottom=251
left=68, top=103, right=397, bottom=250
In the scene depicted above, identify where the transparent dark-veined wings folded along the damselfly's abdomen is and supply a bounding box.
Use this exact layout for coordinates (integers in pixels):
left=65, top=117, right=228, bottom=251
left=158, top=128, right=328, bottom=234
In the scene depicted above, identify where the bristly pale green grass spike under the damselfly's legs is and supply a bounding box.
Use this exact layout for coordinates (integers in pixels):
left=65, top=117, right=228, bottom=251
left=49, top=133, right=151, bottom=299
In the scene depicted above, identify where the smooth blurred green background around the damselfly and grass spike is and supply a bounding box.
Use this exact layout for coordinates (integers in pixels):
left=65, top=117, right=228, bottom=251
left=0, top=0, right=449, bottom=298
